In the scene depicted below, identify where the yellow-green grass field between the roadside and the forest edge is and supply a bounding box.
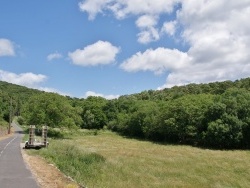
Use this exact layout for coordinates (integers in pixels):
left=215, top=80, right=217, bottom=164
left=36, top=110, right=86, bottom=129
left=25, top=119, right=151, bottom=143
left=27, top=130, right=250, bottom=188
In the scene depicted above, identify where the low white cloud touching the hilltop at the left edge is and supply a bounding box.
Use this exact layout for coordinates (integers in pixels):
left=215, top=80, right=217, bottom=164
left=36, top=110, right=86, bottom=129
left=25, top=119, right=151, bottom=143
left=0, top=70, right=47, bottom=88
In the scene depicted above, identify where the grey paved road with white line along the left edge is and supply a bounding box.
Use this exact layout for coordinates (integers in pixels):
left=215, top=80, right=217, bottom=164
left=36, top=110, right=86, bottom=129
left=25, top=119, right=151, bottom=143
left=0, top=124, right=39, bottom=188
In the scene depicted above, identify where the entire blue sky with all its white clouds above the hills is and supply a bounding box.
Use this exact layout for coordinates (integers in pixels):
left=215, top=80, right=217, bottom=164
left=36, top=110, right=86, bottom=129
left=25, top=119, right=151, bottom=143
left=0, top=0, right=250, bottom=98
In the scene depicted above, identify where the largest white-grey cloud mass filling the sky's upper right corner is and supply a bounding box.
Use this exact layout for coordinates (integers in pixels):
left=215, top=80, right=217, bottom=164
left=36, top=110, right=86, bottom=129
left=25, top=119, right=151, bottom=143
left=163, top=0, right=250, bottom=87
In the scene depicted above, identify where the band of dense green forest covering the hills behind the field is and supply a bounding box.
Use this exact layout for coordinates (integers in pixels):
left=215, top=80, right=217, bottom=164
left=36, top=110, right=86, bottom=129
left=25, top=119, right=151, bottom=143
left=0, top=78, right=250, bottom=149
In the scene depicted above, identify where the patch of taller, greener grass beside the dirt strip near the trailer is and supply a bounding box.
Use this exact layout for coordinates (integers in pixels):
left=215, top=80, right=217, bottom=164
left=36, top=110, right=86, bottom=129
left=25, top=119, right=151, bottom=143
left=32, top=140, right=105, bottom=185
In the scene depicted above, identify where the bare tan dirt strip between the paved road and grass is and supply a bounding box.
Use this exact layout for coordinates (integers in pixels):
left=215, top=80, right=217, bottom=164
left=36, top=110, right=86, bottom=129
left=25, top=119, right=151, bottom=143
left=22, top=150, right=79, bottom=188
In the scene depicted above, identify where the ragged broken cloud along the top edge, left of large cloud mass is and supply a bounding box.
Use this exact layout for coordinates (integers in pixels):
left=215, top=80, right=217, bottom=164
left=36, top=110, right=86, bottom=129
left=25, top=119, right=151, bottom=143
left=79, top=0, right=180, bottom=44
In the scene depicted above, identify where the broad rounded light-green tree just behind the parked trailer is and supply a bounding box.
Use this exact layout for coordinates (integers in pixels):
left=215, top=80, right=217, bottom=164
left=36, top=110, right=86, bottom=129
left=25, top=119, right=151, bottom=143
left=22, top=93, right=82, bottom=128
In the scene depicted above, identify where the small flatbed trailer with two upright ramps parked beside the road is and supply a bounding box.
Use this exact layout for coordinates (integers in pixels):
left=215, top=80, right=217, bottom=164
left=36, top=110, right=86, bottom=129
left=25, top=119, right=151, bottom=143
left=24, top=125, right=49, bottom=149
